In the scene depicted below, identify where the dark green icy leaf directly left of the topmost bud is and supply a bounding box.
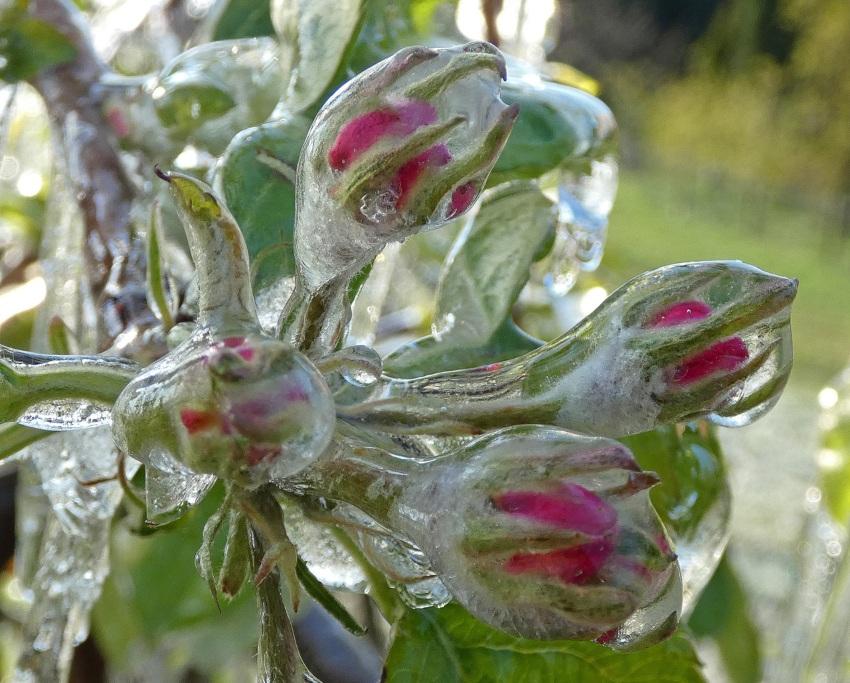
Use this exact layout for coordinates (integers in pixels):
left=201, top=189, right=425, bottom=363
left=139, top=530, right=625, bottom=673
left=215, top=116, right=310, bottom=287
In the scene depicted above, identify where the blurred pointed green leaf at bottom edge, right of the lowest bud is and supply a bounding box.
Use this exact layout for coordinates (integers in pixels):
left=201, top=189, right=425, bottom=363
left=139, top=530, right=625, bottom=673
left=688, top=555, right=762, bottom=683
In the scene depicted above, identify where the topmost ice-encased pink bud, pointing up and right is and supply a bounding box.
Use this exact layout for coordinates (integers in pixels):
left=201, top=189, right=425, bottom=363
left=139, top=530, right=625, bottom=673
left=295, top=43, right=517, bottom=290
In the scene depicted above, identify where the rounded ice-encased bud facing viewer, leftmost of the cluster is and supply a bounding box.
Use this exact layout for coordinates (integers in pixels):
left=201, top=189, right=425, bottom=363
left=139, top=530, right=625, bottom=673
left=113, top=334, right=334, bottom=487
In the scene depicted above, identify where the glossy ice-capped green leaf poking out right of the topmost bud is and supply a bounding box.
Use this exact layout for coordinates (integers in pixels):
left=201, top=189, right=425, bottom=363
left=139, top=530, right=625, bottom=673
left=488, top=79, right=616, bottom=186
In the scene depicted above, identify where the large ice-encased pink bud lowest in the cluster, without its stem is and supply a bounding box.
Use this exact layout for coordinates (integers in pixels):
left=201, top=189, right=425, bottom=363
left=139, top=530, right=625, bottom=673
left=394, top=426, right=681, bottom=647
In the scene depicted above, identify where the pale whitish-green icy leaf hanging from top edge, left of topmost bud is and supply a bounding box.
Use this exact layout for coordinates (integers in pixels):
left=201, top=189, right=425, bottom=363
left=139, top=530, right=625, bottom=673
left=272, top=0, right=365, bottom=112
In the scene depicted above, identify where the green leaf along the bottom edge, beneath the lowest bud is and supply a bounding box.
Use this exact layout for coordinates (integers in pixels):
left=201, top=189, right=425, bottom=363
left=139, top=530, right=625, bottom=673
left=384, top=604, right=705, bottom=683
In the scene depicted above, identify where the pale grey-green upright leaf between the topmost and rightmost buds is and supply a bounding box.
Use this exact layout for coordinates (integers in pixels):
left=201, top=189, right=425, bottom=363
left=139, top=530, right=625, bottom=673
left=432, top=182, right=556, bottom=346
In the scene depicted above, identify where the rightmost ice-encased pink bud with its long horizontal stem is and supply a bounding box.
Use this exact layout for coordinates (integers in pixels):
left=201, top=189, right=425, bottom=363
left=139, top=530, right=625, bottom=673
left=340, top=261, right=797, bottom=437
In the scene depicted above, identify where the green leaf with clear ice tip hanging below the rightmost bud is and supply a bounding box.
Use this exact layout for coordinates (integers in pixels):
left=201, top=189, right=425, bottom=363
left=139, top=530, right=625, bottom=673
left=622, top=422, right=731, bottom=613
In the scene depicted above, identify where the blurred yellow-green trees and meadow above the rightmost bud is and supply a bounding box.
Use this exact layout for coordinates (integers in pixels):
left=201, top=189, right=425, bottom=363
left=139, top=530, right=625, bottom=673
left=551, top=0, right=850, bottom=393
